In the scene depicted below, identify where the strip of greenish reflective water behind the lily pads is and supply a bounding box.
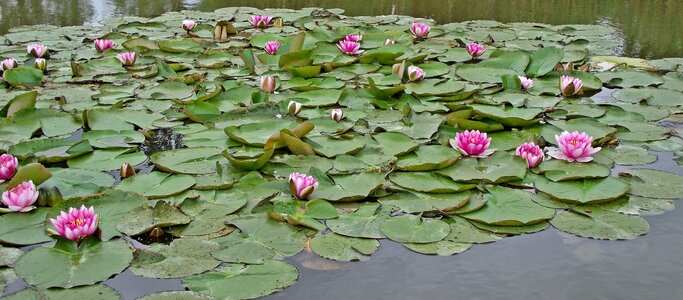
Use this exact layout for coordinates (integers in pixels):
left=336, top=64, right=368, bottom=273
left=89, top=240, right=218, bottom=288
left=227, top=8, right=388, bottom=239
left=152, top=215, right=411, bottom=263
left=0, top=0, right=683, bottom=58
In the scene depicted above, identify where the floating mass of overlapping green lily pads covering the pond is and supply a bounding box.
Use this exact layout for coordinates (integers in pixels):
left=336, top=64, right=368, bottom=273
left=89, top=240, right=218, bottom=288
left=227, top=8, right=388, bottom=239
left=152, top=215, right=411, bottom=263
left=0, top=8, right=683, bottom=299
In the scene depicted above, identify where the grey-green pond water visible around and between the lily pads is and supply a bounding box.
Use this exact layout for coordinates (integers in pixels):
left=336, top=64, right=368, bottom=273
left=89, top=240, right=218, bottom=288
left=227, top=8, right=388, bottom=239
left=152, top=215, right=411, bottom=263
left=0, top=0, right=683, bottom=300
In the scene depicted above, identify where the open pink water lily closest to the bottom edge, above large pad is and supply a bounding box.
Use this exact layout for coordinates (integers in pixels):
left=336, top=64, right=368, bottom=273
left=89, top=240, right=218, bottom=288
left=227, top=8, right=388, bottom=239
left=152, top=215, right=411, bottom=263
left=50, top=205, right=99, bottom=242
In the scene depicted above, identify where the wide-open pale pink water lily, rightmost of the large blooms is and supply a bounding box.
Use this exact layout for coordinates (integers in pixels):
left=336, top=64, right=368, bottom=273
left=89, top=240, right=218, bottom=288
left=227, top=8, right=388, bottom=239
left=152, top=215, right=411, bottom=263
left=548, top=131, right=602, bottom=162
